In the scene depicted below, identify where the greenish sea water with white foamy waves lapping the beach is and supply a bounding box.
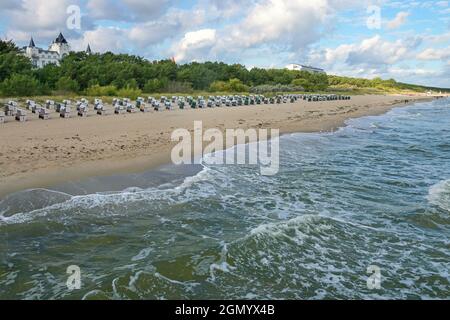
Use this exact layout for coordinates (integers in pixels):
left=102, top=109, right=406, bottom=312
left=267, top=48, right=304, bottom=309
left=0, top=100, right=450, bottom=299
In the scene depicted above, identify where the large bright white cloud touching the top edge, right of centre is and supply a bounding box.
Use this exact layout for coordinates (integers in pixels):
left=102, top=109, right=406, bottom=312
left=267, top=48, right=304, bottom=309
left=172, top=0, right=365, bottom=61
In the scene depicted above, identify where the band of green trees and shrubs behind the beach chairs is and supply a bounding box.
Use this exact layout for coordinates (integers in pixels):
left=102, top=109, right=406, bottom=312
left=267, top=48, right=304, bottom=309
left=0, top=41, right=446, bottom=97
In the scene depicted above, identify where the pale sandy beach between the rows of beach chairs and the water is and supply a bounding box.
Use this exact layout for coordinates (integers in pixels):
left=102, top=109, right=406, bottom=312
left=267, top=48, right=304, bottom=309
left=0, top=95, right=436, bottom=197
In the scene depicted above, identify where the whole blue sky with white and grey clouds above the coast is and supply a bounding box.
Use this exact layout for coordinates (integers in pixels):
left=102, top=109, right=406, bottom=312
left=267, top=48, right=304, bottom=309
left=0, top=0, right=450, bottom=87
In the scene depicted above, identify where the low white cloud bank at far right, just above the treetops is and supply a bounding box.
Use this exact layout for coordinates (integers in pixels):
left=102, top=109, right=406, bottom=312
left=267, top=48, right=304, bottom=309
left=309, top=35, right=450, bottom=87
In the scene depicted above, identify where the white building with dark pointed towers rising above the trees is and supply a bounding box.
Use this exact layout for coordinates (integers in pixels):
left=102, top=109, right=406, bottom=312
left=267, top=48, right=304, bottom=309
left=22, top=33, right=91, bottom=68
